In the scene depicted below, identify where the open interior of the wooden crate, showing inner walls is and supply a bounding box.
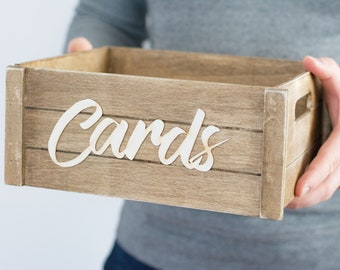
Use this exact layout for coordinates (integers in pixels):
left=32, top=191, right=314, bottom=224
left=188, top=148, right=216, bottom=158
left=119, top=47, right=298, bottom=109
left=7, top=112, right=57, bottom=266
left=21, top=47, right=304, bottom=87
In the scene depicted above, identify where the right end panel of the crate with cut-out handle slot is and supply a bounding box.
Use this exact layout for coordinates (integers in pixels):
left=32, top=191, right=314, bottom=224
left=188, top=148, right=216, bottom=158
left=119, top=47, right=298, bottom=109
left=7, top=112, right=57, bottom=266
left=283, top=72, right=325, bottom=202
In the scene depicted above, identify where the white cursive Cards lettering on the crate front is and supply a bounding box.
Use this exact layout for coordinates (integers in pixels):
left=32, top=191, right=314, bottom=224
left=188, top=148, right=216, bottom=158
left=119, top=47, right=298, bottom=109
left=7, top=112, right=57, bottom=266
left=48, top=99, right=230, bottom=172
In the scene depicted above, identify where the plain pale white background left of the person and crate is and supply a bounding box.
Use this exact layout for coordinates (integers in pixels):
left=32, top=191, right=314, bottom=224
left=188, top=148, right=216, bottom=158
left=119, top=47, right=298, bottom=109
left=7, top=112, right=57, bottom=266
left=0, top=0, right=121, bottom=270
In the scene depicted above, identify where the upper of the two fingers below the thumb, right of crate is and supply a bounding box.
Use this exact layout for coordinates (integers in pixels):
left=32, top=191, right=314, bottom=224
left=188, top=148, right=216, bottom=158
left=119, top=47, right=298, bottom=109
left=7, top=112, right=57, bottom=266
left=295, top=127, right=340, bottom=197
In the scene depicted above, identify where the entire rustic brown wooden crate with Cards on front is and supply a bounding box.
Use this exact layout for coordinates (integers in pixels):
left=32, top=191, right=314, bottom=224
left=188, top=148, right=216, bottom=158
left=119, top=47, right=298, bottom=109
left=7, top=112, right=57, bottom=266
left=5, top=47, right=322, bottom=219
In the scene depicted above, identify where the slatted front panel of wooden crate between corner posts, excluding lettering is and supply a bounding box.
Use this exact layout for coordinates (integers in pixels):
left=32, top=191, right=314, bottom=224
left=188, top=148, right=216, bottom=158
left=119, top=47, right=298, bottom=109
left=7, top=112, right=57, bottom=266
left=21, top=66, right=263, bottom=216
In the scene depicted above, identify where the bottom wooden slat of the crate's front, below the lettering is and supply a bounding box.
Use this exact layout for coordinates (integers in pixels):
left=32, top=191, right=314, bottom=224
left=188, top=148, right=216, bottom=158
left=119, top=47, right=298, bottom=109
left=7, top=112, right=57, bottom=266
left=25, top=149, right=260, bottom=216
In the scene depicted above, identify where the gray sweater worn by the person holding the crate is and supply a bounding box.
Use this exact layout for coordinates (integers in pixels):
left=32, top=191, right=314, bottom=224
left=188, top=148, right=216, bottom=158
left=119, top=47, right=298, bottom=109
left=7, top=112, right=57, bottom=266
left=68, top=0, right=340, bottom=270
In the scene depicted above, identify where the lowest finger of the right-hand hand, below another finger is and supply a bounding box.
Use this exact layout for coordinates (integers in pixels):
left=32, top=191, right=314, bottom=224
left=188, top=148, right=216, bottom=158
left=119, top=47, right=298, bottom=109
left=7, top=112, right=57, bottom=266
left=287, top=162, right=340, bottom=209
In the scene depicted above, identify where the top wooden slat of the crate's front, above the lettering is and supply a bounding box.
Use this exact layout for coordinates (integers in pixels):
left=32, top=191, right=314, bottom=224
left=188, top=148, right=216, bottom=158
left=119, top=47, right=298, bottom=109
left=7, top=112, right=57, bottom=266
left=25, top=69, right=263, bottom=130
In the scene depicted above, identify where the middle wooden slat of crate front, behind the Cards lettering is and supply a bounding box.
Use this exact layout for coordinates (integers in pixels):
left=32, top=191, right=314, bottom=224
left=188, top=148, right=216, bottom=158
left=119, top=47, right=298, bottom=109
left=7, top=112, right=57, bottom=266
left=25, top=108, right=263, bottom=175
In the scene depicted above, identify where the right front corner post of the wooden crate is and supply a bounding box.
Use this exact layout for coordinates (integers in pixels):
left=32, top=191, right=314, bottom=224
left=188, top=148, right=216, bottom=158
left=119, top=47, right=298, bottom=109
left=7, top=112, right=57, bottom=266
left=260, top=89, right=288, bottom=220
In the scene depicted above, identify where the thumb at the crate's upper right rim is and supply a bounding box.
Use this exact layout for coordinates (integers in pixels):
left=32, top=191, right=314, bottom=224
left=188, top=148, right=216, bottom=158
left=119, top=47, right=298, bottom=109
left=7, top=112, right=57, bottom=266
left=303, top=56, right=340, bottom=127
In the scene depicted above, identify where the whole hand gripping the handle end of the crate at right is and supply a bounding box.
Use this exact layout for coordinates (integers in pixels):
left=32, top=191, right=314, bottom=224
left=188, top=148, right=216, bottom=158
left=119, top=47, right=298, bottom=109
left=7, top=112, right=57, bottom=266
left=288, top=56, right=340, bottom=209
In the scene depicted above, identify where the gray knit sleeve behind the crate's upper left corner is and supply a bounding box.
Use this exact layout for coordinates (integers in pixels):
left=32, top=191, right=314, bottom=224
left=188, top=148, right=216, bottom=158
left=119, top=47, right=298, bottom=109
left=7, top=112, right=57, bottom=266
left=65, top=0, right=147, bottom=51
